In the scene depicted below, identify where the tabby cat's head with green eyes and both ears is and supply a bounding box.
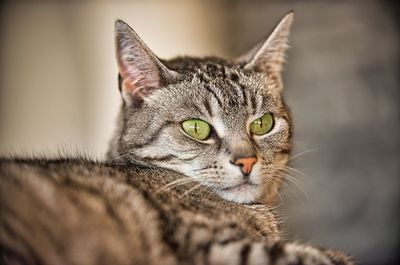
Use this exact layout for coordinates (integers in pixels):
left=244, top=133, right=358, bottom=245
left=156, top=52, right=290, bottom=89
left=108, top=13, right=293, bottom=203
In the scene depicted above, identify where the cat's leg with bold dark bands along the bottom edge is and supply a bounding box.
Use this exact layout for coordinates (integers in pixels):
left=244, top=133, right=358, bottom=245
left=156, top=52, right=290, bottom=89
left=180, top=219, right=353, bottom=265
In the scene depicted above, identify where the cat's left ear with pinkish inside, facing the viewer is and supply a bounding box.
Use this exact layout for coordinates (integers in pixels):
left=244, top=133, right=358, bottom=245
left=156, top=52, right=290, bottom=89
left=115, top=20, right=177, bottom=101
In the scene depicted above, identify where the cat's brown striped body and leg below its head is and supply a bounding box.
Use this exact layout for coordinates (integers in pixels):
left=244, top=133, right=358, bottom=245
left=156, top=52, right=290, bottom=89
left=0, top=159, right=352, bottom=265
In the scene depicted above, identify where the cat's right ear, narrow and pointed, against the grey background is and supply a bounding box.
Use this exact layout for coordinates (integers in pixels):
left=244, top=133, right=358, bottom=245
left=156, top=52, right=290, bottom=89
left=234, top=12, right=294, bottom=74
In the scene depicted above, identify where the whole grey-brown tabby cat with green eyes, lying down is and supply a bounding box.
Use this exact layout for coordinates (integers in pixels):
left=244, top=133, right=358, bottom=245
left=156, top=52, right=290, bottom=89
left=0, top=13, right=353, bottom=265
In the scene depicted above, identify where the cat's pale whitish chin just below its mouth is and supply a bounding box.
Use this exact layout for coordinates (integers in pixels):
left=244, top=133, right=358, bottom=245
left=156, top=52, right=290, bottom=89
left=216, top=184, right=260, bottom=204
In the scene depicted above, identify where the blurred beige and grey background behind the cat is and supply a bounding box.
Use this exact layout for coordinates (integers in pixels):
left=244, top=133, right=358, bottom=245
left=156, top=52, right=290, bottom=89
left=0, top=0, right=400, bottom=265
